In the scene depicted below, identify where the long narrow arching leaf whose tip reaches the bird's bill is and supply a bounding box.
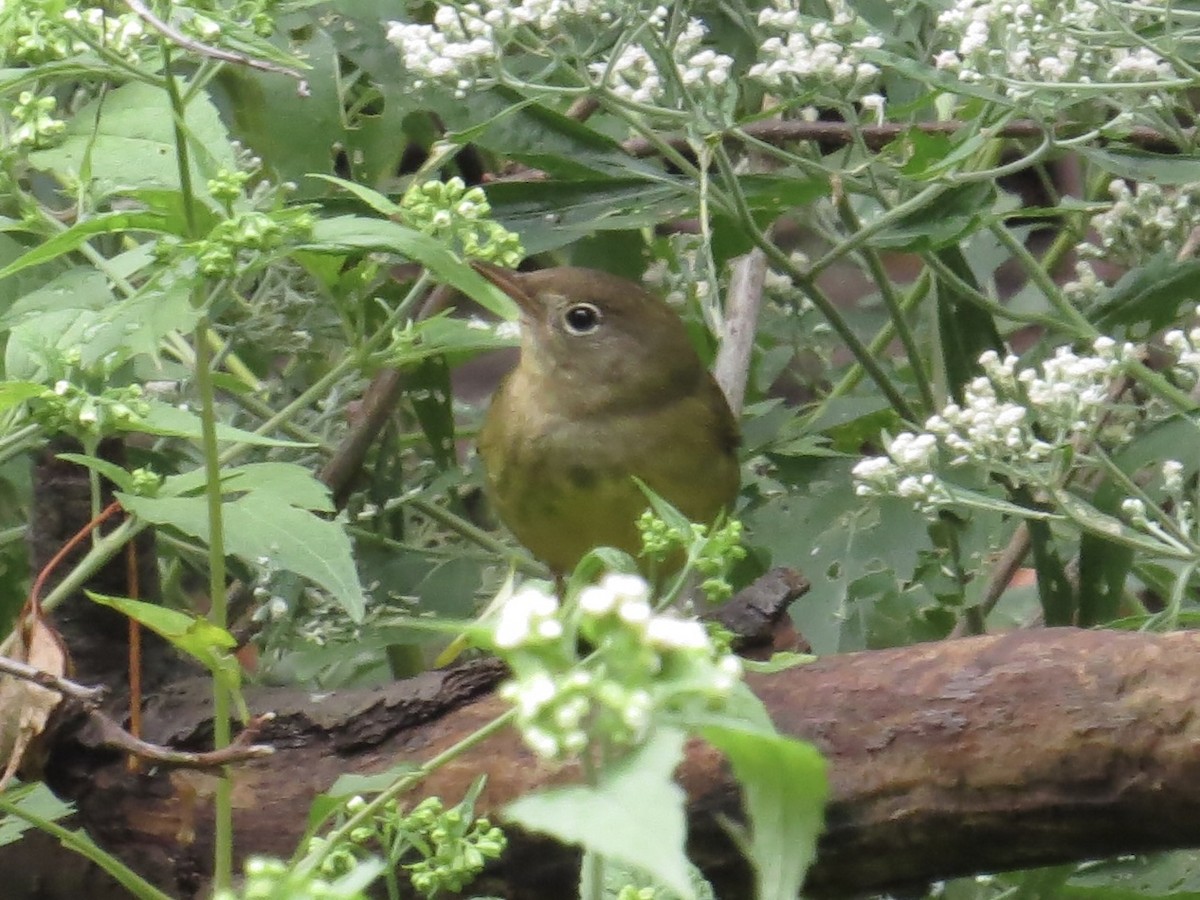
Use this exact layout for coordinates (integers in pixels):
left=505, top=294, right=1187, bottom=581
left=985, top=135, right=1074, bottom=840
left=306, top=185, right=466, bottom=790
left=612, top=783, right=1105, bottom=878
left=308, top=216, right=517, bottom=319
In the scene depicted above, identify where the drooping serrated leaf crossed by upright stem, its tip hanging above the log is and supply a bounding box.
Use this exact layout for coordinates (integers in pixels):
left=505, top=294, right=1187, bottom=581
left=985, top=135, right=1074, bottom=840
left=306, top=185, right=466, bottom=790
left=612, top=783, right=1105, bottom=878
left=118, top=492, right=366, bottom=622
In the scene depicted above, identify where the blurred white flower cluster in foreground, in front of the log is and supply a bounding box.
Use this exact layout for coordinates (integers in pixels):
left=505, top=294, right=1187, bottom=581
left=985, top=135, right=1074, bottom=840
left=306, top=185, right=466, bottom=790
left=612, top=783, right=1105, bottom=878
left=493, top=575, right=742, bottom=760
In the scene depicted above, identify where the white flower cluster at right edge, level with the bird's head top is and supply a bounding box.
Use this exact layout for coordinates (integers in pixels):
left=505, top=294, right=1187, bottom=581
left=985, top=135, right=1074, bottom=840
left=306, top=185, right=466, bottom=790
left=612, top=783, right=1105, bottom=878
left=1063, top=179, right=1200, bottom=306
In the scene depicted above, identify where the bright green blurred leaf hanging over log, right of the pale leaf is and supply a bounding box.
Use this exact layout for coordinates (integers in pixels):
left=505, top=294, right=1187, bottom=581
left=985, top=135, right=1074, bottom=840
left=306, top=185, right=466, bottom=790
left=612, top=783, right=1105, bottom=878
left=700, top=721, right=829, bottom=900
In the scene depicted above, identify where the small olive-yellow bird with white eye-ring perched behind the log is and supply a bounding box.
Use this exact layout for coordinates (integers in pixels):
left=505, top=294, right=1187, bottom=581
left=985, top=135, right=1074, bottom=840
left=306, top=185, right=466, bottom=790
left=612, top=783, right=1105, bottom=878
left=473, top=262, right=739, bottom=576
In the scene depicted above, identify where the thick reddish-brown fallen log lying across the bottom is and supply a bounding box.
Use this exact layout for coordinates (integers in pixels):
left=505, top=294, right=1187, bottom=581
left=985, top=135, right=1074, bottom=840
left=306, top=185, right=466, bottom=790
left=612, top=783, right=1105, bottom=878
left=11, top=629, right=1200, bottom=900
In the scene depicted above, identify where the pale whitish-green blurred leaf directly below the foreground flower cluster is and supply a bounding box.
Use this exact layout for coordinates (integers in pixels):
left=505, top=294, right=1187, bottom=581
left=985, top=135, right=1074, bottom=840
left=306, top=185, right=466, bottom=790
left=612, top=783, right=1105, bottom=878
left=504, top=728, right=696, bottom=900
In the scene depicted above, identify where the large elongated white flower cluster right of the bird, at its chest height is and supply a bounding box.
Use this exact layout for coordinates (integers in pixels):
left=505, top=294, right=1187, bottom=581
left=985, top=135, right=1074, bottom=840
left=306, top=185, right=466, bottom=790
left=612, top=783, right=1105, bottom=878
left=853, top=337, right=1133, bottom=512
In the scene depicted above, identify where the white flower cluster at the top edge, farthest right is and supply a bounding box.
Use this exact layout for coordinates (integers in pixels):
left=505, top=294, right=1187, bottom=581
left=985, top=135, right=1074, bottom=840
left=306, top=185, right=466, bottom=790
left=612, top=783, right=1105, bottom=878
left=934, top=0, right=1178, bottom=98
